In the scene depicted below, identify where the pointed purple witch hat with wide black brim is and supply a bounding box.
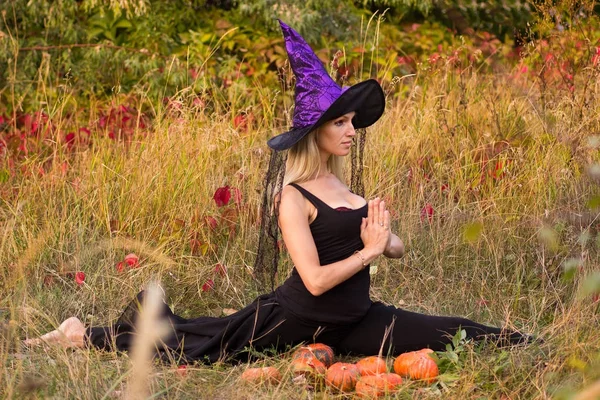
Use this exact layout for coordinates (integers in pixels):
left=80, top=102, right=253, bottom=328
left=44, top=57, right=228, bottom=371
left=267, top=20, right=385, bottom=150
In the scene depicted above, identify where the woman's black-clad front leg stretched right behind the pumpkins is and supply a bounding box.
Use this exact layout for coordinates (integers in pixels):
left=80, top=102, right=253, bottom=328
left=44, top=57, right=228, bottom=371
left=339, top=303, right=529, bottom=355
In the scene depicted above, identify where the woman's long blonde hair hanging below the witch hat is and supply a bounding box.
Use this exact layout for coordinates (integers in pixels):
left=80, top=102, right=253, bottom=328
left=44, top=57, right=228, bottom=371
left=283, top=129, right=344, bottom=187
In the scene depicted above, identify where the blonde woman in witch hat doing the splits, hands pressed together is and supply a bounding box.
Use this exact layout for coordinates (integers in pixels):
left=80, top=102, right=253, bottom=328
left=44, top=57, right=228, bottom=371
left=28, top=21, right=527, bottom=362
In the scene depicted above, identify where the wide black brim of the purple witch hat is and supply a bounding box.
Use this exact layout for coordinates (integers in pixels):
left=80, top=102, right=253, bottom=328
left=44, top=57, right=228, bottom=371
left=267, top=79, right=385, bottom=150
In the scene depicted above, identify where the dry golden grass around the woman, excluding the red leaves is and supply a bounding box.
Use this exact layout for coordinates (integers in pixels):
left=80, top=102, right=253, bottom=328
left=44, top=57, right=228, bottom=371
left=0, top=33, right=600, bottom=399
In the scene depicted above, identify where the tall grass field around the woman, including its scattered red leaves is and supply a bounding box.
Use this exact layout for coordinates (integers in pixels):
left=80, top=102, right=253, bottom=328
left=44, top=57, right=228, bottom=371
left=0, top=2, right=600, bottom=400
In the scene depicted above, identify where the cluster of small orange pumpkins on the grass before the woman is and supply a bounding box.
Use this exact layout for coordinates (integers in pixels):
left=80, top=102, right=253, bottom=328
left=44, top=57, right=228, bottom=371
left=242, top=343, right=439, bottom=398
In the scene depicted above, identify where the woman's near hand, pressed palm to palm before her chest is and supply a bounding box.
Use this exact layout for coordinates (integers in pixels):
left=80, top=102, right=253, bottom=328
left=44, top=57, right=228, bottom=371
left=360, top=197, right=392, bottom=262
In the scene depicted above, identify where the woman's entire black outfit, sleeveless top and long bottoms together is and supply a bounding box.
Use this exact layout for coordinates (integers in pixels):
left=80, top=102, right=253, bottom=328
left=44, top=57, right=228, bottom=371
left=87, top=184, right=523, bottom=363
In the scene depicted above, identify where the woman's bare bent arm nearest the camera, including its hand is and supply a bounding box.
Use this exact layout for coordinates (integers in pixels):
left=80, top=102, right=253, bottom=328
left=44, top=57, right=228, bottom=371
left=279, top=186, right=389, bottom=296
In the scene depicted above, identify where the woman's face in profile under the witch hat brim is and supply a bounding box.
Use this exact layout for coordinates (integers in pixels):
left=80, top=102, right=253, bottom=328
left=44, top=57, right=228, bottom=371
left=317, top=111, right=356, bottom=156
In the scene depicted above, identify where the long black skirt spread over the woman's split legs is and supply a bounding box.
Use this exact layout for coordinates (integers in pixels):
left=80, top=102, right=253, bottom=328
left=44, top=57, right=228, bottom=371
left=87, top=292, right=530, bottom=363
